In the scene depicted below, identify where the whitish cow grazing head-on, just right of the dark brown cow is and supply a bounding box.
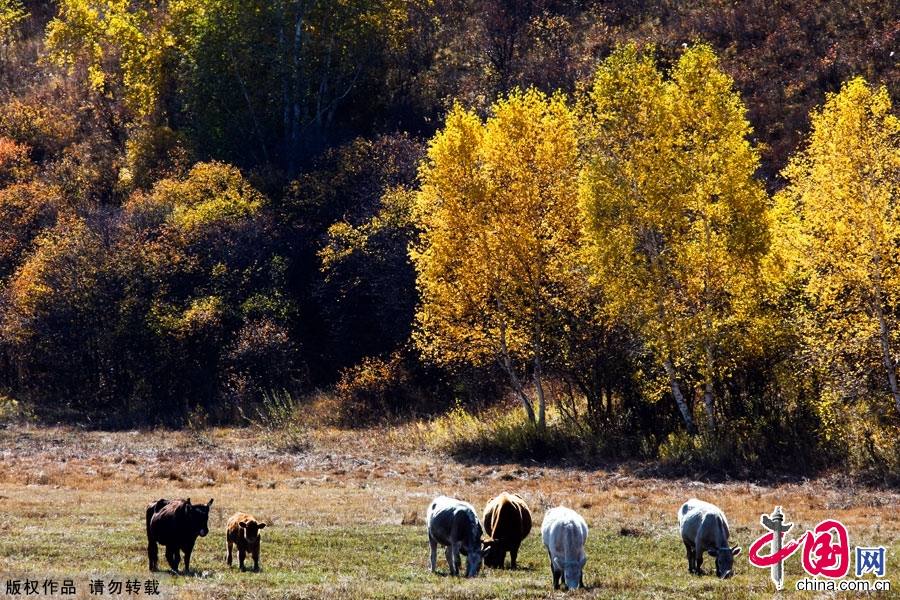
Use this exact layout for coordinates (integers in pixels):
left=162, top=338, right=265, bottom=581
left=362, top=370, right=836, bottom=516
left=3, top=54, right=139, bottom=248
left=541, top=506, right=587, bottom=590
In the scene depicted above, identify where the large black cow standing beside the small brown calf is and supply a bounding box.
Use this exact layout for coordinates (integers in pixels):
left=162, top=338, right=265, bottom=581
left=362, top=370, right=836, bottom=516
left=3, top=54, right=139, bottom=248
left=147, top=498, right=212, bottom=574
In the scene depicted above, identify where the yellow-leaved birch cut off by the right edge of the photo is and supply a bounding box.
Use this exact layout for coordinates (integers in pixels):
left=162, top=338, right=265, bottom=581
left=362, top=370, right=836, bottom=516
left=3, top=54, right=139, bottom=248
left=781, top=78, right=900, bottom=412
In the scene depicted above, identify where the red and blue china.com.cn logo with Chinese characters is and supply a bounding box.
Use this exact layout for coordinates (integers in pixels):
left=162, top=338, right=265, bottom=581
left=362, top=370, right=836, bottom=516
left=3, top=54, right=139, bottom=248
left=748, top=506, right=891, bottom=591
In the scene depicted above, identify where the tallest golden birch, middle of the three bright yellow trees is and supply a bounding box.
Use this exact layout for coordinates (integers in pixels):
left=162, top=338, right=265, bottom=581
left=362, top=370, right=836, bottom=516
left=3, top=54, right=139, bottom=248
left=580, top=45, right=769, bottom=432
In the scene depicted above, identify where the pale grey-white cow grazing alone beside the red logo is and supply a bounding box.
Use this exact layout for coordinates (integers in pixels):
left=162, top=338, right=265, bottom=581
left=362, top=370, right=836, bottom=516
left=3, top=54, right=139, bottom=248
left=678, top=498, right=741, bottom=579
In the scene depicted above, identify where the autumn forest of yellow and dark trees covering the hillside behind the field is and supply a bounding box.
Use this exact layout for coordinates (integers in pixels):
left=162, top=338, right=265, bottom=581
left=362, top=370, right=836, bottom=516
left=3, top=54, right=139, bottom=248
left=0, top=0, right=900, bottom=478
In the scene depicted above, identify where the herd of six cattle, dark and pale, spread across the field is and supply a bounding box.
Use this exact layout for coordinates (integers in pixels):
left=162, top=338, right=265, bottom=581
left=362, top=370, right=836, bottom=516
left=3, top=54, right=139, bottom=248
left=147, top=492, right=741, bottom=589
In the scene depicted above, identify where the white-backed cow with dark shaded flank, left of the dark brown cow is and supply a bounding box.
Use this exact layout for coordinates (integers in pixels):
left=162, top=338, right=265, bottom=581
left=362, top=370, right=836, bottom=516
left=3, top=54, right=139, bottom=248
left=425, top=496, right=481, bottom=577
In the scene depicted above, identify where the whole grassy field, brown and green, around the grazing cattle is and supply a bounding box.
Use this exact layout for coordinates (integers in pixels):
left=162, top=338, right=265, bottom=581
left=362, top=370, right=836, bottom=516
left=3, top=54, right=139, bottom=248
left=0, top=428, right=900, bottom=598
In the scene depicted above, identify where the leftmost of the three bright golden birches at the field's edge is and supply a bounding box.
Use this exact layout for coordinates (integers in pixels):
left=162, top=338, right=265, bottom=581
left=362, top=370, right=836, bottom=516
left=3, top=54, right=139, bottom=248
left=411, top=89, right=579, bottom=427
